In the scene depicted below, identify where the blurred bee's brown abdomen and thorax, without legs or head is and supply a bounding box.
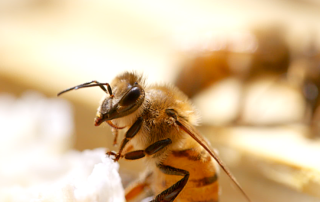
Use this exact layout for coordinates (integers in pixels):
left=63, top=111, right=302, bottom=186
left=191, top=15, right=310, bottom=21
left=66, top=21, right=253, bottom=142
left=176, top=26, right=290, bottom=98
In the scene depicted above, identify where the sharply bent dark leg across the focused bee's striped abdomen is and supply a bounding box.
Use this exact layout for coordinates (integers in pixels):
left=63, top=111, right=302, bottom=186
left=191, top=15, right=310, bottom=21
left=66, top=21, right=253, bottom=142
left=152, top=164, right=189, bottom=202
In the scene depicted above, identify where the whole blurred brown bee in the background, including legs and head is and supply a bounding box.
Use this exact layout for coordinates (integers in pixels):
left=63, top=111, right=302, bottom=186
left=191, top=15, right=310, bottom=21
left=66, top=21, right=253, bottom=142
left=176, top=27, right=320, bottom=135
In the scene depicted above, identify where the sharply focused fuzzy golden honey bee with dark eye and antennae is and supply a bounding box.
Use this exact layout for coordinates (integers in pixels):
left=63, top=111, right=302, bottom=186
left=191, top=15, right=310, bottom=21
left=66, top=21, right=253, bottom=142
left=58, top=72, right=250, bottom=202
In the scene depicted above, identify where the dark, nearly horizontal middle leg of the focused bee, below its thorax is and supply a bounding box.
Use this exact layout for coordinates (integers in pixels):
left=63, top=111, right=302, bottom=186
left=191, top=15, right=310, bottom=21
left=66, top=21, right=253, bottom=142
left=124, top=138, right=172, bottom=160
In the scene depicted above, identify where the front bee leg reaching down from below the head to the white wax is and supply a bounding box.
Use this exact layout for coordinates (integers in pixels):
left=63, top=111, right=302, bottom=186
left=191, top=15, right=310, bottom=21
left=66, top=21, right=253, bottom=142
left=107, top=117, right=143, bottom=161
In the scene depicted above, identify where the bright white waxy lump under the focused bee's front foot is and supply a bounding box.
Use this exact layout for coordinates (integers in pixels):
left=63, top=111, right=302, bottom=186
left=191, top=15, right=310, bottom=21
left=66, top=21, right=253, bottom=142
left=0, top=92, right=125, bottom=202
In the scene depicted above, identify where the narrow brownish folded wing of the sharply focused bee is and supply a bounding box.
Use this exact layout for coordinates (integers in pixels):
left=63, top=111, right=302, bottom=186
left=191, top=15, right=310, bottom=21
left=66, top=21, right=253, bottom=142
left=176, top=118, right=251, bottom=202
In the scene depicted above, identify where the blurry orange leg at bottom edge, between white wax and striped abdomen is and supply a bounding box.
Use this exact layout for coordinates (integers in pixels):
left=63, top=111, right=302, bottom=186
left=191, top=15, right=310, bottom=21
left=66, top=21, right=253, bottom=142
left=125, top=172, right=152, bottom=202
